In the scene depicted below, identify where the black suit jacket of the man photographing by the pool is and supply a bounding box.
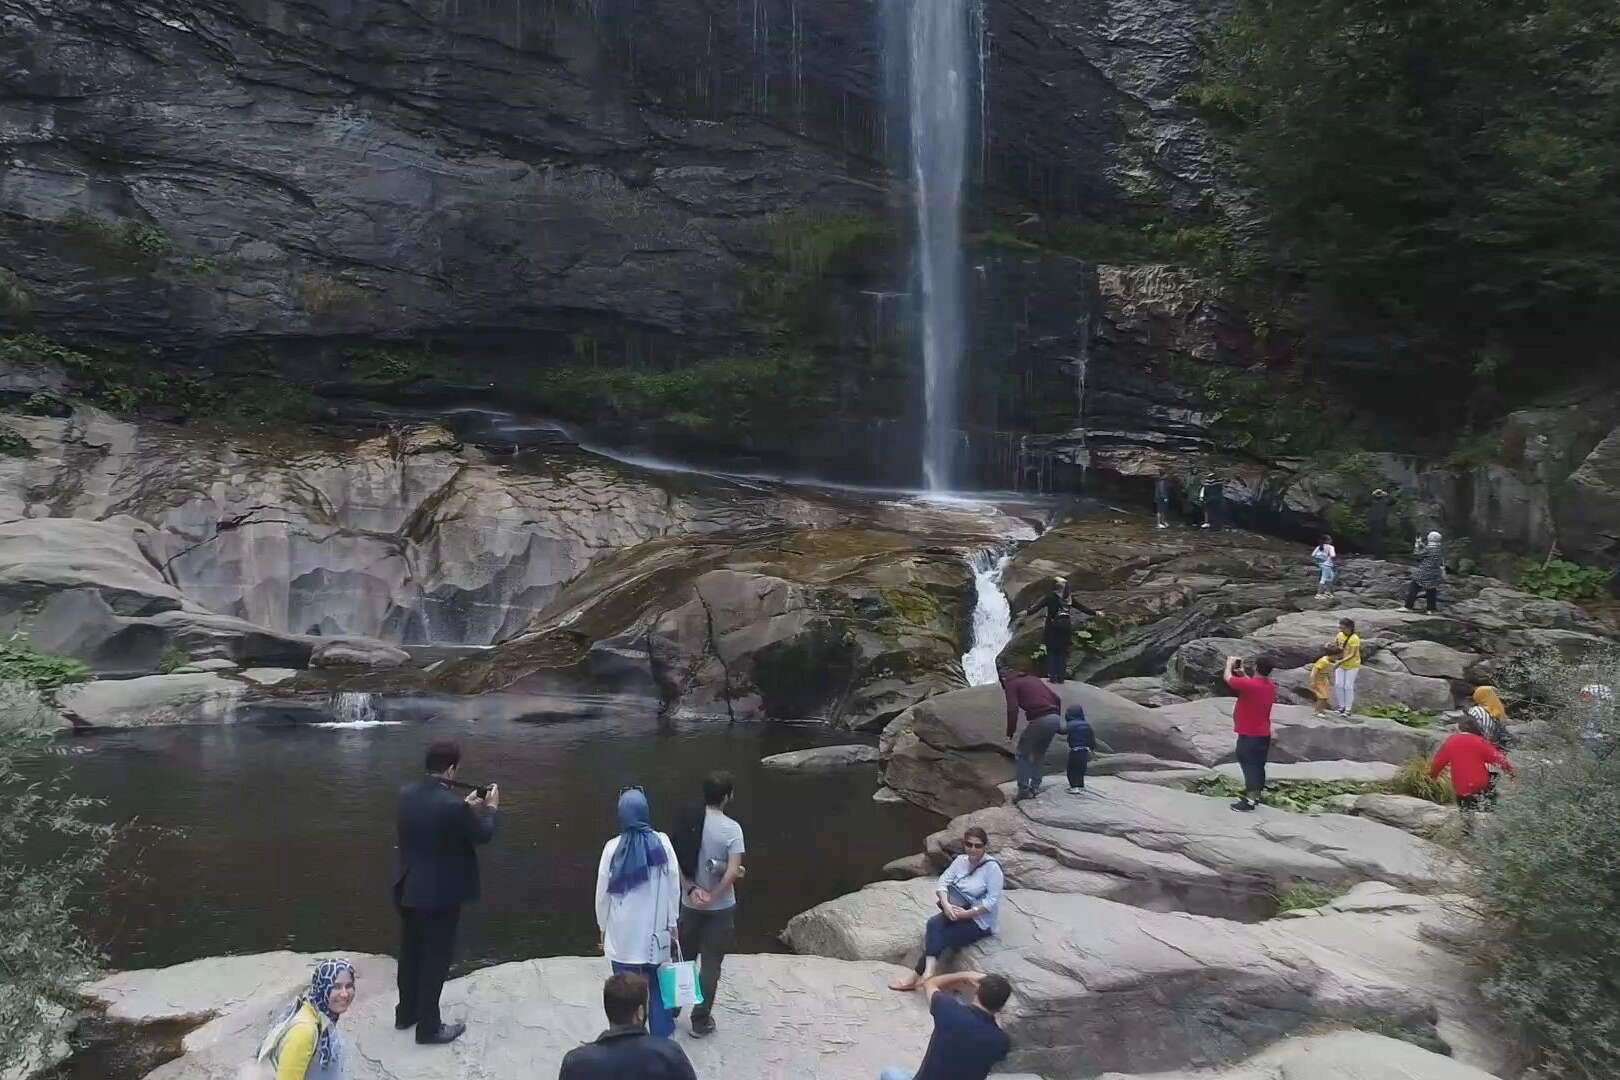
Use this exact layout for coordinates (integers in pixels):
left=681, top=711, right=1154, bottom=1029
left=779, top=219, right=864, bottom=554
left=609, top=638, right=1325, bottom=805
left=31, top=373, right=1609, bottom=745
left=394, top=777, right=496, bottom=908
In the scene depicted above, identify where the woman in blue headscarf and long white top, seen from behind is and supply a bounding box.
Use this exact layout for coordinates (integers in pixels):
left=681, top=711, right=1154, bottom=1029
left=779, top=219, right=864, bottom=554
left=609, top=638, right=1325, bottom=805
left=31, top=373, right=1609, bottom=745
left=596, top=787, right=680, bottom=1038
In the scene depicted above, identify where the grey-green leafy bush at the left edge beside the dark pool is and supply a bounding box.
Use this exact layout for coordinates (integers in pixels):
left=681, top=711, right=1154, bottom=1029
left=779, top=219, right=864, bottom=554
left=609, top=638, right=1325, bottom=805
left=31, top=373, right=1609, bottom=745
left=0, top=682, right=113, bottom=1075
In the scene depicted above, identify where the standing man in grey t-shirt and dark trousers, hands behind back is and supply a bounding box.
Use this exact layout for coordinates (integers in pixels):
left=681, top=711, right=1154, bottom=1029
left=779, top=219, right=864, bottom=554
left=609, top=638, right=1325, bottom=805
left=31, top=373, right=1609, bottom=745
left=679, top=772, right=744, bottom=1038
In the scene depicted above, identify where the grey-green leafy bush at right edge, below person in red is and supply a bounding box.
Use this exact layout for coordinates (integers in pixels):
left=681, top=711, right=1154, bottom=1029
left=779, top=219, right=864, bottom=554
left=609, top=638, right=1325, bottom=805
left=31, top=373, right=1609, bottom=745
left=1471, top=649, right=1620, bottom=1080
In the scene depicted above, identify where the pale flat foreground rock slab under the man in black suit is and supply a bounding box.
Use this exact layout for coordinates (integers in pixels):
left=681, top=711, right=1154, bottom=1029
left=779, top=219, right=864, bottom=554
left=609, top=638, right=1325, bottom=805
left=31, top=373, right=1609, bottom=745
left=94, top=952, right=930, bottom=1080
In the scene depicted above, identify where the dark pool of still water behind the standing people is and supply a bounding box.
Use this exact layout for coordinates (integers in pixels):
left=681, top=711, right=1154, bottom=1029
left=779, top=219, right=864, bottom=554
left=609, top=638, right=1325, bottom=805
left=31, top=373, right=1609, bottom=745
left=71, top=701, right=940, bottom=972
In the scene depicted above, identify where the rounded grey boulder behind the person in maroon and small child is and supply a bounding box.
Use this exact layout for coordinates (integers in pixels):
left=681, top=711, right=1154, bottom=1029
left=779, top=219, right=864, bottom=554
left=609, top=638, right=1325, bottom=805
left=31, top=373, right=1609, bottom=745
left=880, top=682, right=1199, bottom=814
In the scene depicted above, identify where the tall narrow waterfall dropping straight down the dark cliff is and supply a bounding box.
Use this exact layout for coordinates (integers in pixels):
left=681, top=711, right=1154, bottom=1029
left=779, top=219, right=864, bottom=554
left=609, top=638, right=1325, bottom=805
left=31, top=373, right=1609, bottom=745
left=896, top=0, right=983, bottom=491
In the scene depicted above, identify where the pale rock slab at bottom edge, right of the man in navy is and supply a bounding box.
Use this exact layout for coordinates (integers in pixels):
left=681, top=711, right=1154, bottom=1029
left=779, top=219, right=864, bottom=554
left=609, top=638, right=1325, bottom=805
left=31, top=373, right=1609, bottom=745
left=1098, top=1031, right=1494, bottom=1080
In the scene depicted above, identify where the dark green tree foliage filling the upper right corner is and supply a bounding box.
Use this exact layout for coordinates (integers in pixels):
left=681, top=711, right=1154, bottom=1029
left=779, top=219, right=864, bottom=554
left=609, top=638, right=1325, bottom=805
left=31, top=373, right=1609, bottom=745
left=1189, top=0, right=1620, bottom=393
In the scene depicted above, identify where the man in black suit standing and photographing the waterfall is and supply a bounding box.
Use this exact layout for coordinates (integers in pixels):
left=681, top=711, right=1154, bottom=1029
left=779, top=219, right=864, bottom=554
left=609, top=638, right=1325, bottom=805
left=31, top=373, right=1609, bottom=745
left=394, top=742, right=501, bottom=1046
